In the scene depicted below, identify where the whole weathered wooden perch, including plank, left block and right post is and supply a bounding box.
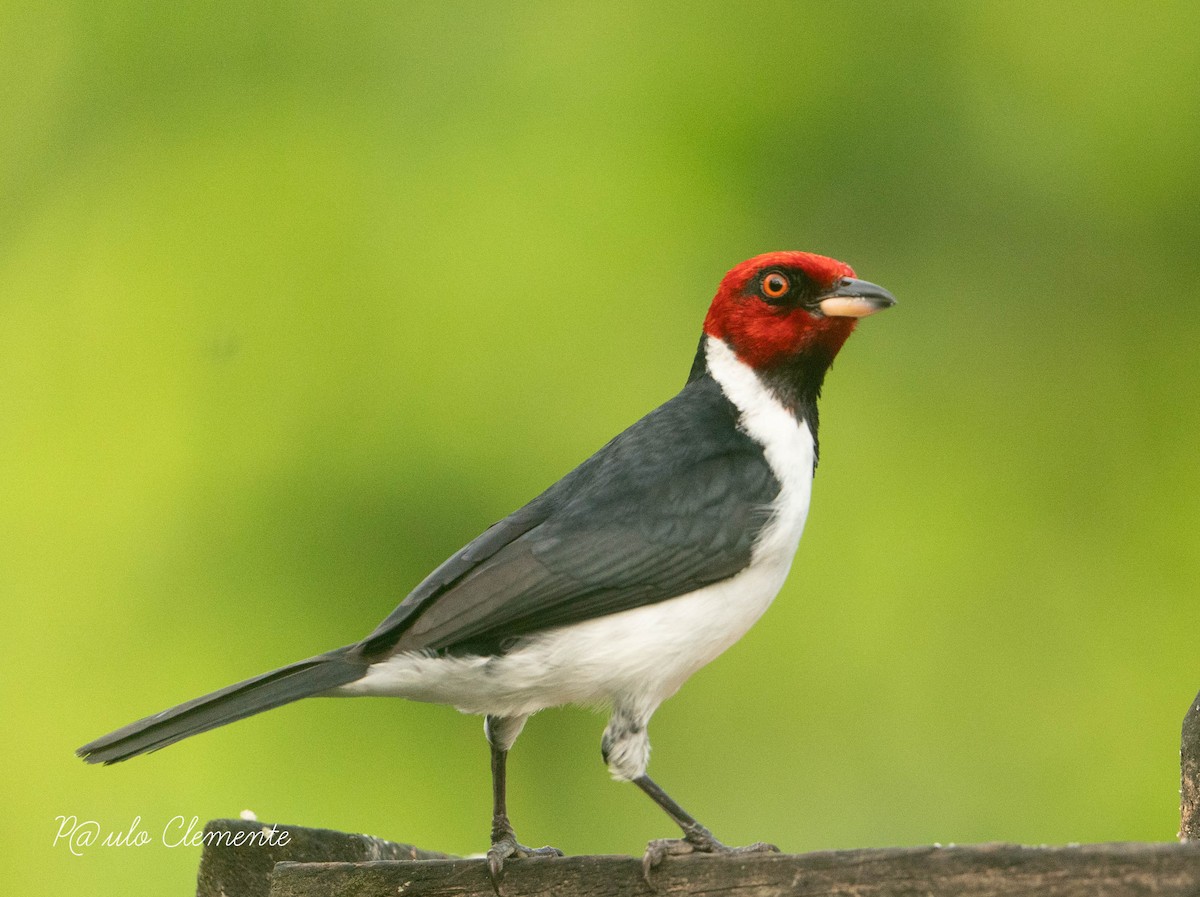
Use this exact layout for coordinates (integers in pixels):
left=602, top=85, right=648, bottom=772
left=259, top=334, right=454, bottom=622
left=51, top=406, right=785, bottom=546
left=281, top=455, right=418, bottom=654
left=197, top=694, right=1200, bottom=897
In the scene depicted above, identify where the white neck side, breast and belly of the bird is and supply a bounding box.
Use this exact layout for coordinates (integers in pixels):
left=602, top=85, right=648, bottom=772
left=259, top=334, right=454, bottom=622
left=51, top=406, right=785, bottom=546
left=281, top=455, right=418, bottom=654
left=338, top=337, right=814, bottom=716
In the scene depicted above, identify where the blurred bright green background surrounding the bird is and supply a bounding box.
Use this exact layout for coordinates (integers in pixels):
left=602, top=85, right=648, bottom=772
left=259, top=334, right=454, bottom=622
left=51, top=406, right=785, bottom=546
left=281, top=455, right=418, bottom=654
left=0, top=0, right=1200, bottom=895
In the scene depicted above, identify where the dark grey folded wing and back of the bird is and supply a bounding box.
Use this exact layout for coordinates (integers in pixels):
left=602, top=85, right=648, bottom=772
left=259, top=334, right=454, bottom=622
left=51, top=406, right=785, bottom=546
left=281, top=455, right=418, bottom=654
left=361, top=377, right=779, bottom=656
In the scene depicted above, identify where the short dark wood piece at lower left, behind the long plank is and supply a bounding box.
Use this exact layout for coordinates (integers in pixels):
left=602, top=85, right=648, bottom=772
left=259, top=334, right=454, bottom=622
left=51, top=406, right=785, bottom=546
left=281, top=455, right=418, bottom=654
left=196, top=819, right=448, bottom=897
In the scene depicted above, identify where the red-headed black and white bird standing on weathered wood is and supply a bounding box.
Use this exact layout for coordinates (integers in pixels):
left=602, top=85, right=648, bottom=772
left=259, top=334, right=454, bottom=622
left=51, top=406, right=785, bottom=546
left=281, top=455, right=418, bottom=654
left=77, top=251, right=895, bottom=893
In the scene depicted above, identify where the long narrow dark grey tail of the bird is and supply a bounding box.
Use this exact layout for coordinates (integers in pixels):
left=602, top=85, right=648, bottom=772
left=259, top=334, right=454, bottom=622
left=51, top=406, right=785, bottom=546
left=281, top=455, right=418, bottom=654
left=76, top=648, right=367, bottom=764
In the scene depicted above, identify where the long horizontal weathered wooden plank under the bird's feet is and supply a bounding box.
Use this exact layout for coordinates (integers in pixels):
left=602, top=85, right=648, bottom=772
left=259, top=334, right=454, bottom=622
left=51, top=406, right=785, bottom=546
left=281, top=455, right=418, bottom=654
left=270, top=843, right=1200, bottom=897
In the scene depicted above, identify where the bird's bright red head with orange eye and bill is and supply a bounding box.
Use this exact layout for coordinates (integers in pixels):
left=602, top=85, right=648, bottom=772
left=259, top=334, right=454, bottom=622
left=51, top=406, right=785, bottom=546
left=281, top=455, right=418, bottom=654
left=704, top=252, right=895, bottom=371
